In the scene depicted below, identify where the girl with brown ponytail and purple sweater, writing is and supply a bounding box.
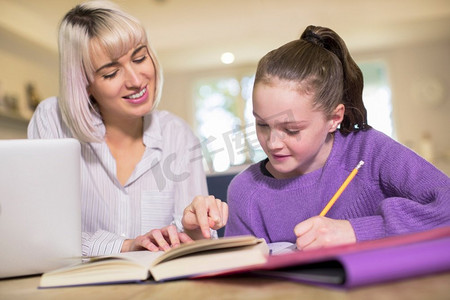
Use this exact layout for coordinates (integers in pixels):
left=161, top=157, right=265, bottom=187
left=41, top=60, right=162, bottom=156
left=225, top=26, right=450, bottom=249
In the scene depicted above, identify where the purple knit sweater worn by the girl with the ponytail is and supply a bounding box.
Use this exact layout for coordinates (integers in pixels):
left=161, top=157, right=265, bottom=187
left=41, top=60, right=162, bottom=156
left=225, top=129, right=450, bottom=243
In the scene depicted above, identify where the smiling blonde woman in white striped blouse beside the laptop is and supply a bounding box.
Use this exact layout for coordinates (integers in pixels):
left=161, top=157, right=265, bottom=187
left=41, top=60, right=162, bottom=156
left=28, top=1, right=227, bottom=255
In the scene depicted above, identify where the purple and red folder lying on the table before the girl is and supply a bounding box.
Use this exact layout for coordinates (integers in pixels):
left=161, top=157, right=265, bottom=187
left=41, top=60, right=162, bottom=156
left=252, top=227, right=450, bottom=288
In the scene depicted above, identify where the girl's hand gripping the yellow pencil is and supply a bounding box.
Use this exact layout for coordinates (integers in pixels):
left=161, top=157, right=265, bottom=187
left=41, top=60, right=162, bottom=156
left=294, top=216, right=356, bottom=250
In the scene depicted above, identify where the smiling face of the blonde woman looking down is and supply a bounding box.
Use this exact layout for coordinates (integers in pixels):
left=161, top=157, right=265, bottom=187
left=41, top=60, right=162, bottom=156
left=88, top=45, right=156, bottom=124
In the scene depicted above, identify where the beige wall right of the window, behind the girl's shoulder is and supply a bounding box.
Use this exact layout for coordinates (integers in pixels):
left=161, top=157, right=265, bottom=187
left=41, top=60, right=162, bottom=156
left=355, top=37, right=450, bottom=174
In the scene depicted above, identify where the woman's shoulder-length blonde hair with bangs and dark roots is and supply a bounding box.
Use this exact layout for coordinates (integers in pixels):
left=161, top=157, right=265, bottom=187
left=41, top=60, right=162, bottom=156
left=58, top=1, right=163, bottom=142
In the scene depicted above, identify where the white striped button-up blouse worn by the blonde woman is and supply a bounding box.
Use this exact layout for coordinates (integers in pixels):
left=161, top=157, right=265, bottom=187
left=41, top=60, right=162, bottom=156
left=28, top=97, right=207, bottom=255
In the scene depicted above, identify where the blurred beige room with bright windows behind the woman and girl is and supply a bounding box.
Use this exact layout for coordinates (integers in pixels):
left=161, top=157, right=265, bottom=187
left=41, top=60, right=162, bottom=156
left=0, top=0, right=450, bottom=175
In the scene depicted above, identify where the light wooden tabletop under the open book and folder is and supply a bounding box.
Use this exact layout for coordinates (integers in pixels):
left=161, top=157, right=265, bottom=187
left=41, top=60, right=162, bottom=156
left=0, top=272, right=450, bottom=300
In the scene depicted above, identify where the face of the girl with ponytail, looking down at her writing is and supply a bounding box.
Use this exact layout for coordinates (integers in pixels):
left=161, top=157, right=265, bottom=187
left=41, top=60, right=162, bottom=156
left=253, top=79, right=344, bottom=178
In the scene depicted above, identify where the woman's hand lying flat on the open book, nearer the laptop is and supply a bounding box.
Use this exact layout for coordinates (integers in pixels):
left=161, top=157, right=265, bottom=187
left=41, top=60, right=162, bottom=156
left=121, top=225, right=192, bottom=252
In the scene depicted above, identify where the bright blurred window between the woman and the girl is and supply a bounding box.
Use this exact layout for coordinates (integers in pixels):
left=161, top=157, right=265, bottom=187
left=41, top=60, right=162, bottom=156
left=195, top=75, right=265, bottom=173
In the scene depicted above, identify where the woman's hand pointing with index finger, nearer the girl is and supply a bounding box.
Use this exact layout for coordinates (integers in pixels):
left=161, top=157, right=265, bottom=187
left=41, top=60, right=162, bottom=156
left=181, top=196, right=228, bottom=239
